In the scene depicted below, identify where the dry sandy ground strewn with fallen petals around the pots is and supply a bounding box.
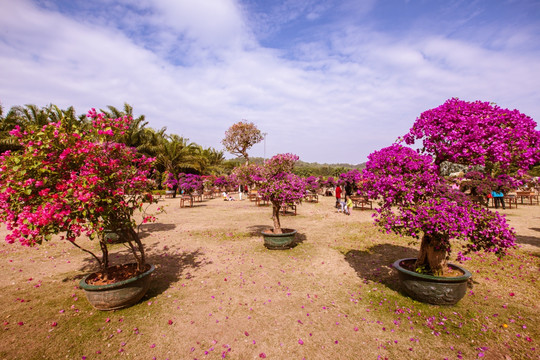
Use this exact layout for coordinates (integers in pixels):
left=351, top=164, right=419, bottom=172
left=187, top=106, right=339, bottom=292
left=0, top=196, right=540, bottom=359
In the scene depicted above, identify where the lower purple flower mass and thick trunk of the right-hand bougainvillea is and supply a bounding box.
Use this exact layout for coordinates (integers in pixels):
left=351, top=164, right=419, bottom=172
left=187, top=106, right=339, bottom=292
left=363, top=144, right=515, bottom=275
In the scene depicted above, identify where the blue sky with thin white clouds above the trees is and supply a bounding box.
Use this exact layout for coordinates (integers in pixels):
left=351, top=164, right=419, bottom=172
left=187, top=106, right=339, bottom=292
left=0, top=0, right=540, bottom=164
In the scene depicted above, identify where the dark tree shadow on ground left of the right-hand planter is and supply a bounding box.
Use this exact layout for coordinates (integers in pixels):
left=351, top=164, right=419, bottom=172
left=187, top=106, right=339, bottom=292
left=345, top=244, right=418, bottom=291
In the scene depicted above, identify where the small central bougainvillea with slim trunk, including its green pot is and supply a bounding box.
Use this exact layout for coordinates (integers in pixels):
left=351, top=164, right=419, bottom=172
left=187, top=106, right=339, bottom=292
left=256, top=154, right=306, bottom=249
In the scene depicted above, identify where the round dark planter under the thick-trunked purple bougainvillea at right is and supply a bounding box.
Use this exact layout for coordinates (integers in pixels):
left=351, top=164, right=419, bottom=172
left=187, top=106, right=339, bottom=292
left=394, top=258, right=472, bottom=305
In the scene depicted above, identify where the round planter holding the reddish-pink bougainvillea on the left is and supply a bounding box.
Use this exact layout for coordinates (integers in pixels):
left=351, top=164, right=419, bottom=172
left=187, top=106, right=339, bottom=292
left=79, top=265, right=156, bottom=310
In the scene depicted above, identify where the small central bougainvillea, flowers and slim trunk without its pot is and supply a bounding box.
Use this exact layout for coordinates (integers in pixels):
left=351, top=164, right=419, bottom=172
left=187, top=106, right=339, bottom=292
left=259, top=154, right=306, bottom=234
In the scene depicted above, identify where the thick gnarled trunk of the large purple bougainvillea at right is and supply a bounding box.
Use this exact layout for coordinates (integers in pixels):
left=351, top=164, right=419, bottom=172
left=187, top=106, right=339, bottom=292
left=415, top=234, right=448, bottom=276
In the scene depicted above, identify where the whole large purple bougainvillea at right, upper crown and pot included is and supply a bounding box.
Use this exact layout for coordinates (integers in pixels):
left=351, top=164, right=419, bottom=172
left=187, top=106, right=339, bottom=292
left=362, top=99, right=540, bottom=304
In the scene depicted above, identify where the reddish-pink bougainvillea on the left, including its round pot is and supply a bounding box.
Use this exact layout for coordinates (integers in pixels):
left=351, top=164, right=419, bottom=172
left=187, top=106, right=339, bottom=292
left=0, top=109, right=160, bottom=309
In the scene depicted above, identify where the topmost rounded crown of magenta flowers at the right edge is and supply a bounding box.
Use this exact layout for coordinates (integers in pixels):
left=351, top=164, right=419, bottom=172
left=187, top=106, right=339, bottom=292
left=404, top=98, right=540, bottom=173
